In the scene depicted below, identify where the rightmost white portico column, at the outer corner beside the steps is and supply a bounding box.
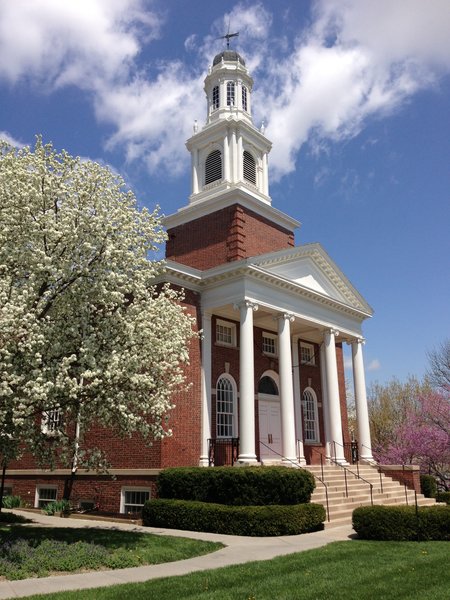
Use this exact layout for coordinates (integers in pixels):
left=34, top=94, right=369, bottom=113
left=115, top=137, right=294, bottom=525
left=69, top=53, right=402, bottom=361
left=352, top=338, right=374, bottom=462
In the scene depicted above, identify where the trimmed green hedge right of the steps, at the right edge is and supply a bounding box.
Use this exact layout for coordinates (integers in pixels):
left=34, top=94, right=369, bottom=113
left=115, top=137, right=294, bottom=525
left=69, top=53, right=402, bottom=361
left=353, top=506, right=450, bottom=541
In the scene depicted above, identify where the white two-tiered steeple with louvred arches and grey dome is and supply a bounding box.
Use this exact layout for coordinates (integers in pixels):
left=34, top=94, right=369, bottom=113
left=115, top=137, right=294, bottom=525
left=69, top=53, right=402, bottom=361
left=186, top=50, right=272, bottom=205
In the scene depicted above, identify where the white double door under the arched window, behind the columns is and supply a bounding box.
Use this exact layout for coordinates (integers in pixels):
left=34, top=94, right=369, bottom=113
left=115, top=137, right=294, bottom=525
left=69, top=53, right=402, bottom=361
left=258, top=394, right=282, bottom=461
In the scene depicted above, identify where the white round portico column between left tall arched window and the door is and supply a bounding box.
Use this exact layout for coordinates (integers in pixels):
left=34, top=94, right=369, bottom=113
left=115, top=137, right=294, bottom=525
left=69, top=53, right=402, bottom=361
left=238, top=300, right=258, bottom=464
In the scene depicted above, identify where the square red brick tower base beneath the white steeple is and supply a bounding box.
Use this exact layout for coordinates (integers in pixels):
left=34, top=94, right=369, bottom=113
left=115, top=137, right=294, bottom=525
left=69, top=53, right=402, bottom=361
left=166, top=204, right=294, bottom=270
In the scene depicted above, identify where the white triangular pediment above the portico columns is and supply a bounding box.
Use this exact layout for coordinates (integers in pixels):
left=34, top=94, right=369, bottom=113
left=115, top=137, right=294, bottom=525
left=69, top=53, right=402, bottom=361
left=252, top=244, right=372, bottom=313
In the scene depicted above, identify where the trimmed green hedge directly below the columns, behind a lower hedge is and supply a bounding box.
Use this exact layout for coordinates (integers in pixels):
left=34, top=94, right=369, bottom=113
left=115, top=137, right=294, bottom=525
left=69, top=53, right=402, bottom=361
left=158, top=467, right=315, bottom=506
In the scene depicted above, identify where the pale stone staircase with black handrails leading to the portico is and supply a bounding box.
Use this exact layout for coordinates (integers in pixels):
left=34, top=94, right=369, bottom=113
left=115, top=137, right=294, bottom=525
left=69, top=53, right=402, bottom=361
left=304, top=465, right=436, bottom=528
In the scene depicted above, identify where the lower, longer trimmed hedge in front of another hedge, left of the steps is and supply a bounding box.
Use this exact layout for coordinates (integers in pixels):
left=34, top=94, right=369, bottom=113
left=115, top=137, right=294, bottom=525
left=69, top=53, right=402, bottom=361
left=142, top=499, right=326, bottom=536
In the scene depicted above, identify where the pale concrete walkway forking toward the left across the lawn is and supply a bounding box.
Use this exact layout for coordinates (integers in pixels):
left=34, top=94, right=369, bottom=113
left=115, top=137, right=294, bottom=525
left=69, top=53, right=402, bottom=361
left=0, top=510, right=354, bottom=599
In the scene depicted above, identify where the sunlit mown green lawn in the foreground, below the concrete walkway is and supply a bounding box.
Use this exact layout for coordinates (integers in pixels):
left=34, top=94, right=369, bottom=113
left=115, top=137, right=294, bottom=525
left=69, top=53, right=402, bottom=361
left=19, top=540, right=450, bottom=600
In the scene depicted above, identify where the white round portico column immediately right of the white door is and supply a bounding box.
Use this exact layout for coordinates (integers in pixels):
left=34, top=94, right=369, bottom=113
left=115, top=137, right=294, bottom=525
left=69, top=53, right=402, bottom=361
left=278, top=313, right=297, bottom=464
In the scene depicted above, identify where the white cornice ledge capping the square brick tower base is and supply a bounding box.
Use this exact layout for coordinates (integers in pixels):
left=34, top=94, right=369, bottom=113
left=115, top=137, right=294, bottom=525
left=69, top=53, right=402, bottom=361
left=163, top=186, right=300, bottom=231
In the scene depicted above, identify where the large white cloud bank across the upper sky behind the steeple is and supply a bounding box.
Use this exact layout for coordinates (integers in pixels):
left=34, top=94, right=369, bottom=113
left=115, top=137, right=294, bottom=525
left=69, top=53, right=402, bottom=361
left=0, top=0, right=450, bottom=184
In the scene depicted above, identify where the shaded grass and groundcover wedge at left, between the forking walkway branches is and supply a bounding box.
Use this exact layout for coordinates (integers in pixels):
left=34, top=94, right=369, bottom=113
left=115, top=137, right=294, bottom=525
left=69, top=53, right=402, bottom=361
left=0, top=513, right=223, bottom=579
